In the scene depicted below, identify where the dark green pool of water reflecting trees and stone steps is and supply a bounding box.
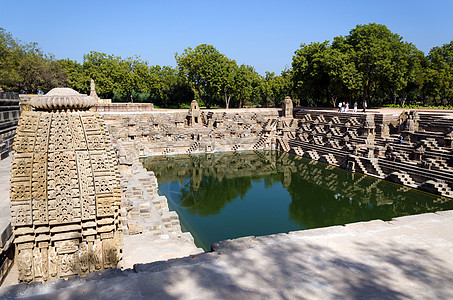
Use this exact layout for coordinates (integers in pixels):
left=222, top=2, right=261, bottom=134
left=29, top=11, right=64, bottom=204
left=143, top=151, right=453, bottom=248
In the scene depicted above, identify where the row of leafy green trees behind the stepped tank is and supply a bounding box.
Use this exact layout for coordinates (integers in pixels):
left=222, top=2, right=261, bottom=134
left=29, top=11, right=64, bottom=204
left=0, top=23, right=453, bottom=108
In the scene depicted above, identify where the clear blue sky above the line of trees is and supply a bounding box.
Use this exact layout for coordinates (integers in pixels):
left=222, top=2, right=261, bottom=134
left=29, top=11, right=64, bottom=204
left=0, top=0, right=453, bottom=75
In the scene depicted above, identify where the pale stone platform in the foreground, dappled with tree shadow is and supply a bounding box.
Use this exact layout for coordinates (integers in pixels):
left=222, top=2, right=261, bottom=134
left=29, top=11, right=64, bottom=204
left=0, top=211, right=453, bottom=300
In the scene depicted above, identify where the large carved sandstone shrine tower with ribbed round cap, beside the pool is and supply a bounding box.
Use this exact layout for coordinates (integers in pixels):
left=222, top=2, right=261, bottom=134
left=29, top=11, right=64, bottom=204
left=11, top=88, right=122, bottom=282
